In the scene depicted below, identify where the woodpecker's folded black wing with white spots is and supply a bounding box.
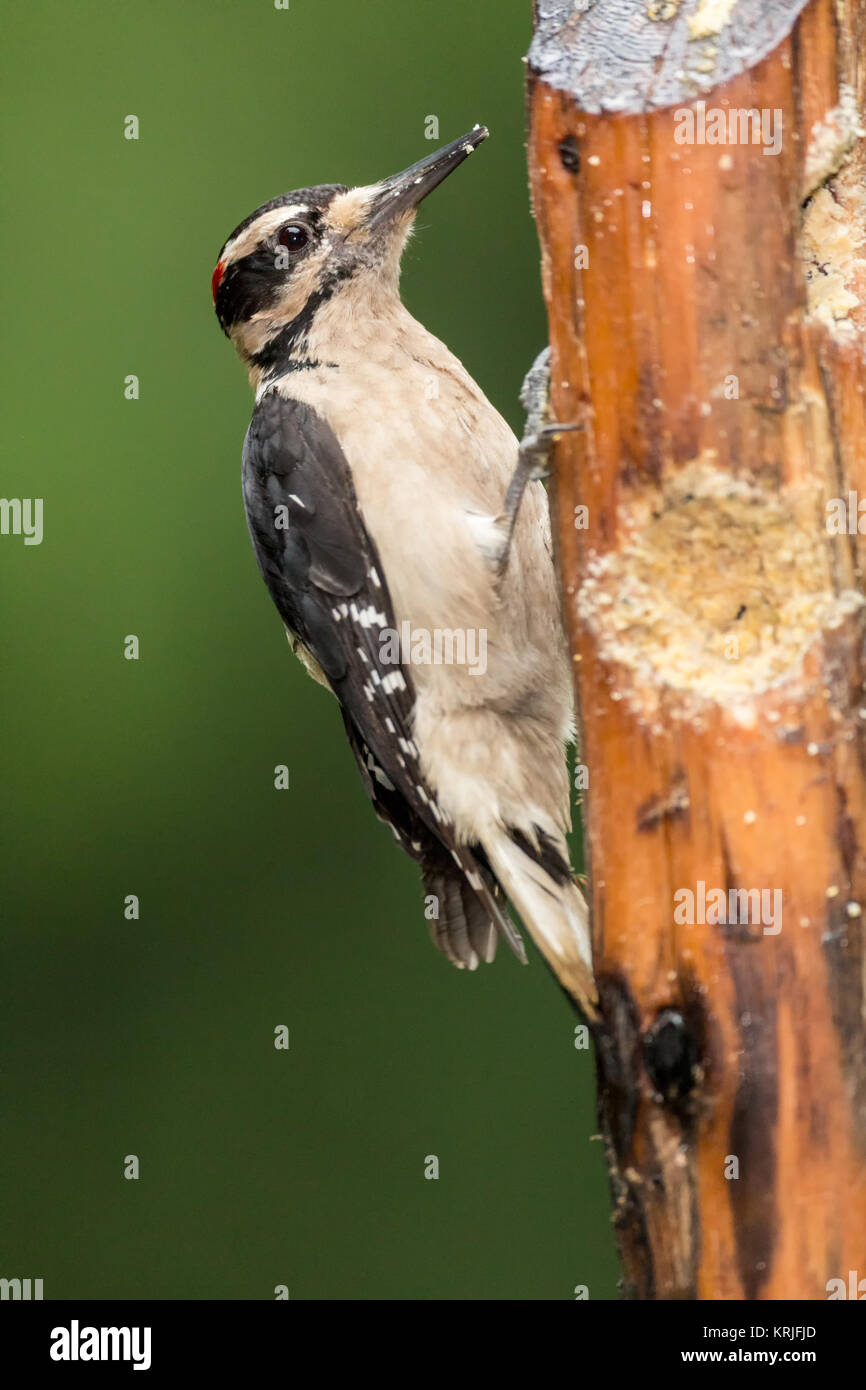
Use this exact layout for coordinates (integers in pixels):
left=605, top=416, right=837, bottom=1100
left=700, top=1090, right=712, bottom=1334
left=237, top=391, right=525, bottom=965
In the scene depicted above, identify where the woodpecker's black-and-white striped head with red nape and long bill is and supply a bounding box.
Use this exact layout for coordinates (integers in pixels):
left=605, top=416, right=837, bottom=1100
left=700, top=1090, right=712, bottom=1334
left=211, top=125, right=488, bottom=374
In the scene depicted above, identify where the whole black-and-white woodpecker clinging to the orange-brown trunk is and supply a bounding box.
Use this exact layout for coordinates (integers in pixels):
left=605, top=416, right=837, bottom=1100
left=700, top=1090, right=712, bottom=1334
left=213, top=125, right=595, bottom=1015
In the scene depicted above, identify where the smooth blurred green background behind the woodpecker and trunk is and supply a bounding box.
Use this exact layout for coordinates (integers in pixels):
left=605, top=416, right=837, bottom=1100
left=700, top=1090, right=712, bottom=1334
left=0, top=0, right=617, bottom=1300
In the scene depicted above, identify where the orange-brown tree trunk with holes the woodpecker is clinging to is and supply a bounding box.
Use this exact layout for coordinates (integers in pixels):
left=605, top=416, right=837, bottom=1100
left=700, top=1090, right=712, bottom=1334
left=530, top=0, right=866, bottom=1298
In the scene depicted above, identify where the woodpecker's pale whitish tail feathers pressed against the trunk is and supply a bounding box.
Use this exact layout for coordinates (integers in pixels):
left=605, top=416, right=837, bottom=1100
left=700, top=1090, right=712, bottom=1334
left=484, top=826, right=598, bottom=1019
